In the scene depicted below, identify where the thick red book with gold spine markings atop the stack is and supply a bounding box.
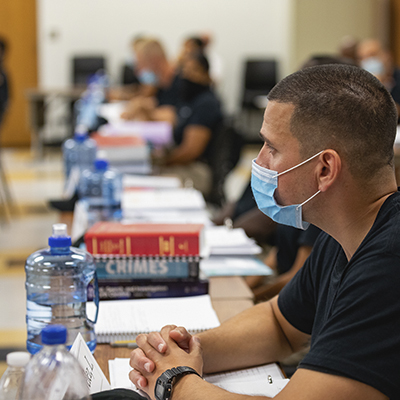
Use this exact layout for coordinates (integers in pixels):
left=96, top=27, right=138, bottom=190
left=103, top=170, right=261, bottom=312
left=85, top=222, right=204, bottom=257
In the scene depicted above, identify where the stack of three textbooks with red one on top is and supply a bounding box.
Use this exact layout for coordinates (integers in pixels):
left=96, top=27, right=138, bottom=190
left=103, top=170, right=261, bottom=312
left=85, top=222, right=208, bottom=300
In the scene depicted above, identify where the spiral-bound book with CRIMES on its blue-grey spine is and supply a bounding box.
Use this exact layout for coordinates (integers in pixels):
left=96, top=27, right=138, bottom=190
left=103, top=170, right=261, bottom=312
left=95, top=256, right=200, bottom=279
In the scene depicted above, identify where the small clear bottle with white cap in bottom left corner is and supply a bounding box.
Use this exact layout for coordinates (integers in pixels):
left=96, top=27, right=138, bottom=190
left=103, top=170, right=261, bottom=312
left=0, top=351, right=31, bottom=400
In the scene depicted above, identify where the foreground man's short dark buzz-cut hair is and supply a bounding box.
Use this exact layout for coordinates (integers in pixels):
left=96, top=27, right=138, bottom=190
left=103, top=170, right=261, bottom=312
left=268, top=65, right=397, bottom=177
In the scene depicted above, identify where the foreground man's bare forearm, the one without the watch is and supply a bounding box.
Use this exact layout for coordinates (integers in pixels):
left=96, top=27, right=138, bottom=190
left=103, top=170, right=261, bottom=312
left=198, top=299, right=292, bottom=373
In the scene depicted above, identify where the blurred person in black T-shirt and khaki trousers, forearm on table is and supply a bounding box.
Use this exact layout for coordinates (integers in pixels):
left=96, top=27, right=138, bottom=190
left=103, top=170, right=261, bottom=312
left=154, top=53, right=223, bottom=195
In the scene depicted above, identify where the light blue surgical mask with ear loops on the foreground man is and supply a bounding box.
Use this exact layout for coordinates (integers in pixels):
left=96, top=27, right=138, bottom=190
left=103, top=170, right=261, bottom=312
left=251, top=150, right=324, bottom=230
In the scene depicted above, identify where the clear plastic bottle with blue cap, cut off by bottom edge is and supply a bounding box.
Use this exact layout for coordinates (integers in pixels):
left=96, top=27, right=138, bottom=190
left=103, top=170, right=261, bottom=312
left=19, top=325, right=90, bottom=400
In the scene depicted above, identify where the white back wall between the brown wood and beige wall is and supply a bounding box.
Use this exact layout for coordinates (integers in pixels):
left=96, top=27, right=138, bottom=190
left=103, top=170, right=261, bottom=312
left=37, top=0, right=291, bottom=112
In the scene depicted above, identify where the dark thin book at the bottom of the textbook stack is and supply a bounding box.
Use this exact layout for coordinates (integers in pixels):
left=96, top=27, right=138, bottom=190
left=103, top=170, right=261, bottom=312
left=88, top=277, right=209, bottom=300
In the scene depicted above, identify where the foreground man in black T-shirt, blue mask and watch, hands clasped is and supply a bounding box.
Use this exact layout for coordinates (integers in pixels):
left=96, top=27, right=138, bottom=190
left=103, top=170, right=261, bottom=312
left=130, top=65, right=400, bottom=400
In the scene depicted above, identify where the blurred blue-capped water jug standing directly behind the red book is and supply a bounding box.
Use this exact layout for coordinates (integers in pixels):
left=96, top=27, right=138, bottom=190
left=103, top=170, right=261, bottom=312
left=78, top=151, right=122, bottom=226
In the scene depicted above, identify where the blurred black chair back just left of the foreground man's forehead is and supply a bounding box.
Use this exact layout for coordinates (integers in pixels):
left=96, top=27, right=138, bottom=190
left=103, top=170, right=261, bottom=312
left=242, top=59, right=277, bottom=109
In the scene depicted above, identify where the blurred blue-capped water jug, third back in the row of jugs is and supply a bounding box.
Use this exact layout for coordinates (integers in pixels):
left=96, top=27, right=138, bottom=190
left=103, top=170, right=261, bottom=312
left=62, top=126, right=97, bottom=179
